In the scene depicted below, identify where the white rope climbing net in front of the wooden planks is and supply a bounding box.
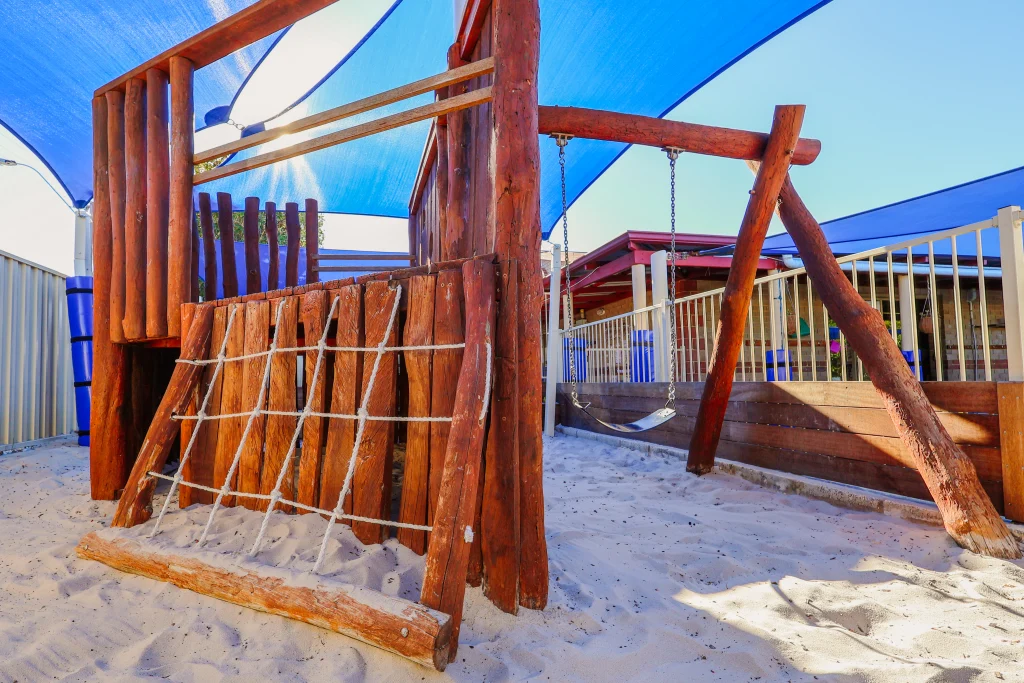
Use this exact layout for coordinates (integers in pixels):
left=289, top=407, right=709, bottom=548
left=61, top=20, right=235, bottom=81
left=148, top=286, right=490, bottom=572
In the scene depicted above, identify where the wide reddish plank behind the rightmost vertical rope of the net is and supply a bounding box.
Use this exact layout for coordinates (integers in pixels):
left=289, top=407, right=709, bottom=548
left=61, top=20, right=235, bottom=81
left=352, top=283, right=398, bottom=545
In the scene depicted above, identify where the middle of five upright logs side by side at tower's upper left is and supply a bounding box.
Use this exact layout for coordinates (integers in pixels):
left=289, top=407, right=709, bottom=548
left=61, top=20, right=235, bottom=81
left=124, top=78, right=146, bottom=341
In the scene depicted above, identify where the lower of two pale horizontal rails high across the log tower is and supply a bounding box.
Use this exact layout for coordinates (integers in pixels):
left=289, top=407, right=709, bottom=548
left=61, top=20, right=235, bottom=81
left=193, top=87, right=490, bottom=185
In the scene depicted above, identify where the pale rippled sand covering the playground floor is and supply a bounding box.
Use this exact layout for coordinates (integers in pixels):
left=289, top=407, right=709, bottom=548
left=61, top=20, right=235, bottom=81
left=0, top=436, right=1024, bottom=683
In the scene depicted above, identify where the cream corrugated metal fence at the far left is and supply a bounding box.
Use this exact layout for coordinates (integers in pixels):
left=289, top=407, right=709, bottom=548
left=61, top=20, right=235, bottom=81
left=0, top=251, right=76, bottom=445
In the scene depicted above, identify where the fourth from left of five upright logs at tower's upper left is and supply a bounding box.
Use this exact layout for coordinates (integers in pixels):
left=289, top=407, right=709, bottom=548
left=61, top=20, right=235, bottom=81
left=145, top=69, right=168, bottom=339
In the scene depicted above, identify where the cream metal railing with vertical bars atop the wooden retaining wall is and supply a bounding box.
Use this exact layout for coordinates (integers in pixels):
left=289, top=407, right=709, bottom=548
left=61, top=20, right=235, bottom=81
left=548, top=207, right=1024, bottom=393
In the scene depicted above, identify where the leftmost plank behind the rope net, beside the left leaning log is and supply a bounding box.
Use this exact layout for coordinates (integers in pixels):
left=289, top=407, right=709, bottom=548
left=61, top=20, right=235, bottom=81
left=185, top=308, right=227, bottom=508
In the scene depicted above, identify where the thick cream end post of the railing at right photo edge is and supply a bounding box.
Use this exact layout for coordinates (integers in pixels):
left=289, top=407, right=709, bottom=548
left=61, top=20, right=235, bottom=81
left=996, top=206, right=1024, bottom=382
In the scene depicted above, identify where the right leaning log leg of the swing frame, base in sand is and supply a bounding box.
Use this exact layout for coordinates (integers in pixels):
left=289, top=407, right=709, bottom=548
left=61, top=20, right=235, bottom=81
left=779, top=177, right=1021, bottom=559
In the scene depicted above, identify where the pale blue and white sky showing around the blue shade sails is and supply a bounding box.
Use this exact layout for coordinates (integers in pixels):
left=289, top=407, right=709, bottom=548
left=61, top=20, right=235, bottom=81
left=0, top=0, right=1024, bottom=272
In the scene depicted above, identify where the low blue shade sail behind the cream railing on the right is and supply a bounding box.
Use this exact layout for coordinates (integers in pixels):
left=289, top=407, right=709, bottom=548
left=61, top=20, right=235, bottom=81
left=761, top=167, right=1024, bottom=258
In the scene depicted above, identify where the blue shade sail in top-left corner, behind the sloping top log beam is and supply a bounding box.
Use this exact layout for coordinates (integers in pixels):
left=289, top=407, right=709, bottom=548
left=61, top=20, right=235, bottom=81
left=0, top=0, right=275, bottom=206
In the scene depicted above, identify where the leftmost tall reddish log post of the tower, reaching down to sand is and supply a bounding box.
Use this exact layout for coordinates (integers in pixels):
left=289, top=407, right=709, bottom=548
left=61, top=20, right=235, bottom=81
left=89, top=97, right=128, bottom=501
